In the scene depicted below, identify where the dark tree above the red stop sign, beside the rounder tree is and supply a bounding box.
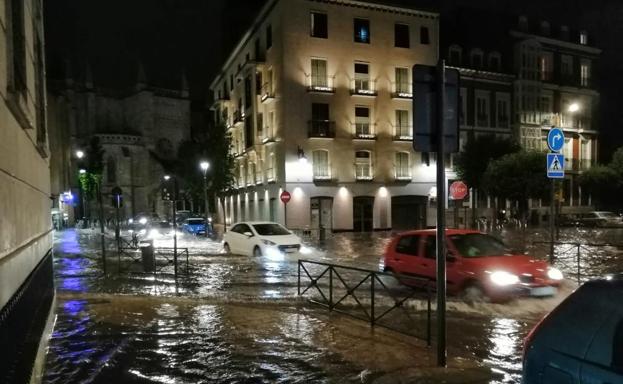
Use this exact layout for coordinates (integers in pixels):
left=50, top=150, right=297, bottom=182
left=454, top=134, right=521, bottom=223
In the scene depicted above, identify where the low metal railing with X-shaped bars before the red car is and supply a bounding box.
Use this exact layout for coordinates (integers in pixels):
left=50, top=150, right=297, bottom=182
left=297, top=260, right=432, bottom=346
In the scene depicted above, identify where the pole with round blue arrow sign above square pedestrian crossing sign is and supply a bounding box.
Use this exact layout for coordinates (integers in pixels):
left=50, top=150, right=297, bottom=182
left=546, top=127, right=565, bottom=263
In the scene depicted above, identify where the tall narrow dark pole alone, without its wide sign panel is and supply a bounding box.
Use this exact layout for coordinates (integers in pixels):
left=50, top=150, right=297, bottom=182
left=436, top=60, right=447, bottom=367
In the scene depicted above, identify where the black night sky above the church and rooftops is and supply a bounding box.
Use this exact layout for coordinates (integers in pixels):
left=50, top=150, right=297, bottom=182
left=44, top=0, right=623, bottom=155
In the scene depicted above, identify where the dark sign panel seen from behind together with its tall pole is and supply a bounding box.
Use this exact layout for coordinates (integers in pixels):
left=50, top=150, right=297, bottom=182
left=412, top=60, right=460, bottom=367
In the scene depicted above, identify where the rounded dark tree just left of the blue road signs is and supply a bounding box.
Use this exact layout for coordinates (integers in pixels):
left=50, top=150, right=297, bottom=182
left=483, top=151, right=551, bottom=222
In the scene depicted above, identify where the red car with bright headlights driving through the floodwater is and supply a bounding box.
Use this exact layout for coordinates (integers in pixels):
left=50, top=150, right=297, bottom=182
left=384, top=229, right=563, bottom=301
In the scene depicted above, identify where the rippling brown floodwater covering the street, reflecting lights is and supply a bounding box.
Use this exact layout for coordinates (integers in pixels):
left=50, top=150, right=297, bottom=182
left=44, top=229, right=623, bottom=383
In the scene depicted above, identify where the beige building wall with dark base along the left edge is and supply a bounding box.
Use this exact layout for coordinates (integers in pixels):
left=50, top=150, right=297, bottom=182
left=0, top=0, right=54, bottom=383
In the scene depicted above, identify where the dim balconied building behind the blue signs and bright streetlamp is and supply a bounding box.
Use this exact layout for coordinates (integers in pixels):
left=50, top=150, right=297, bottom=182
left=509, top=16, right=601, bottom=211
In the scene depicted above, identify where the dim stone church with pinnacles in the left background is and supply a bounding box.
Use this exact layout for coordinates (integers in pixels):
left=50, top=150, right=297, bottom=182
left=48, top=60, right=191, bottom=223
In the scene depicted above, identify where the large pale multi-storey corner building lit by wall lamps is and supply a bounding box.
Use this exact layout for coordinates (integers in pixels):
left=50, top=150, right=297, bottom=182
left=211, top=0, right=439, bottom=231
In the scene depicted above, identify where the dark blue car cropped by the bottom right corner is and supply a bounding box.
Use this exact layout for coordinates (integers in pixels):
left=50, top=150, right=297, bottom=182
left=522, top=275, right=623, bottom=384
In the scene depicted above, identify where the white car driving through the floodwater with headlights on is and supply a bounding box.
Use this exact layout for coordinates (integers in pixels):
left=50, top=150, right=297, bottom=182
left=223, top=222, right=301, bottom=256
